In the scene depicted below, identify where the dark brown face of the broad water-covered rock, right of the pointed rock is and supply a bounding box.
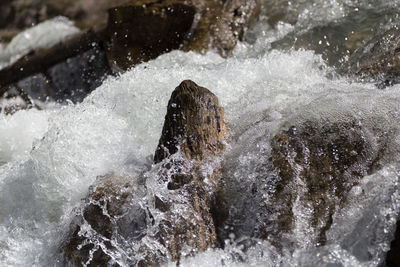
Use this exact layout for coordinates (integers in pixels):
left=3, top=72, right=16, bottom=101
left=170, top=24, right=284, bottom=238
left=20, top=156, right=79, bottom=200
left=254, top=120, right=386, bottom=247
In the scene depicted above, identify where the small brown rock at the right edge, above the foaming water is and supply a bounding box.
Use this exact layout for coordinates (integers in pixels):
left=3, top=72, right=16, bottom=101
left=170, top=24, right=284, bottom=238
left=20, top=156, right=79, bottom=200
left=349, top=27, right=400, bottom=88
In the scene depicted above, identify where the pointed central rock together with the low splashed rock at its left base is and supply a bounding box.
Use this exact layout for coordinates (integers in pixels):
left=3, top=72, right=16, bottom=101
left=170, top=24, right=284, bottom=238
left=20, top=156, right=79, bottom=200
left=62, top=81, right=227, bottom=266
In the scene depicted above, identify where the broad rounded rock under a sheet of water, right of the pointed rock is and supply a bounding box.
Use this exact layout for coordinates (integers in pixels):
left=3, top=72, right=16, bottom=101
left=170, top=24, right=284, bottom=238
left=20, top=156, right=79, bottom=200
left=215, top=116, right=392, bottom=251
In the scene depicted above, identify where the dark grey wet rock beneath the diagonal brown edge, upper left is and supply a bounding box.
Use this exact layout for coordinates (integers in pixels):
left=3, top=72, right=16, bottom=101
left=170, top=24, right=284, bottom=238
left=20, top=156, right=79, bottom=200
left=0, top=43, right=112, bottom=103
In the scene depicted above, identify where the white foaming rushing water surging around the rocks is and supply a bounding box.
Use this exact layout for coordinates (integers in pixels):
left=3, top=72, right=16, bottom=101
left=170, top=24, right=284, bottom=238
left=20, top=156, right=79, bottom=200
left=0, top=0, right=400, bottom=266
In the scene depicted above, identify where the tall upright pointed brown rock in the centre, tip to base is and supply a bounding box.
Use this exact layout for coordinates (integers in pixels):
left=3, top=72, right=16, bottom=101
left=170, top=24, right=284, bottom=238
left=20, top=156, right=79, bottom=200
left=148, top=81, right=227, bottom=262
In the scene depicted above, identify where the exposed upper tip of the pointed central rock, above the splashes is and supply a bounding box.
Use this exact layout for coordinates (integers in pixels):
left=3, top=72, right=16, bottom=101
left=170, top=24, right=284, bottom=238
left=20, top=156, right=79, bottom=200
left=154, top=80, right=226, bottom=163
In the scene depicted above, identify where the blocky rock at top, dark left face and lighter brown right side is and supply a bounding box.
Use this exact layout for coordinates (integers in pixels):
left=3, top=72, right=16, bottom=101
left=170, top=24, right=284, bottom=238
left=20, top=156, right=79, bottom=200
left=108, top=0, right=260, bottom=69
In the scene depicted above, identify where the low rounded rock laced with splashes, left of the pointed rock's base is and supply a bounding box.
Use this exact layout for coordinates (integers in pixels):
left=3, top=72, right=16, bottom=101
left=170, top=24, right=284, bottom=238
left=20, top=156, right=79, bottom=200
left=62, top=174, right=148, bottom=266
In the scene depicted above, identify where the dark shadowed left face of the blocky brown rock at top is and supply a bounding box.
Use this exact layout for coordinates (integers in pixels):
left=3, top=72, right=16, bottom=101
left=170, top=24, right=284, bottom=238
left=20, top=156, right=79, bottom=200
left=108, top=3, right=195, bottom=69
